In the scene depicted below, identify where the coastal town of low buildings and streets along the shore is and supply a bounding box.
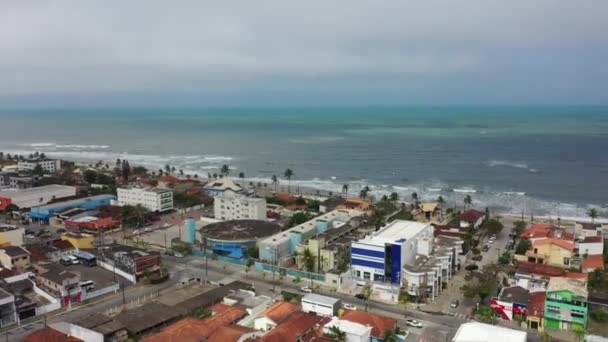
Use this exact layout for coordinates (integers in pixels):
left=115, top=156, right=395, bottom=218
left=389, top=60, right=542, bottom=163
left=0, top=151, right=608, bottom=342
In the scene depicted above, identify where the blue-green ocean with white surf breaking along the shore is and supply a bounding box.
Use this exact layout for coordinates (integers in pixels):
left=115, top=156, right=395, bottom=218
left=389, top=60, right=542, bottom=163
left=0, top=106, right=608, bottom=218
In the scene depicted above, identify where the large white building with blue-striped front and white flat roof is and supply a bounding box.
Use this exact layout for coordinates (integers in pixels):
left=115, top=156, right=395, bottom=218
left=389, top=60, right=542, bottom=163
left=351, top=220, right=433, bottom=284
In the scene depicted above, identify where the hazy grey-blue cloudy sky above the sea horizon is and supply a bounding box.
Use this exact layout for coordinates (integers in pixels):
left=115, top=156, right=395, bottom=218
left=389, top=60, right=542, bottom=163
left=0, top=0, right=608, bottom=107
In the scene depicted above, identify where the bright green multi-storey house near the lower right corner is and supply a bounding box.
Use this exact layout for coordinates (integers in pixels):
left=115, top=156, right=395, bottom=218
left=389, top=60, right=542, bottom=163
left=545, top=277, right=588, bottom=331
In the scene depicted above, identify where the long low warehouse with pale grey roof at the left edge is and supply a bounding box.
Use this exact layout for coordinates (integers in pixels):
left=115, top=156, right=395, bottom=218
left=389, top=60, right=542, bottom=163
left=0, top=184, right=76, bottom=210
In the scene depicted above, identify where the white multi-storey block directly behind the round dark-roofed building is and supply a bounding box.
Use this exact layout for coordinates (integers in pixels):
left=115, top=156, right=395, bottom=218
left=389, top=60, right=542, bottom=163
left=213, top=191, right=266, bottom=220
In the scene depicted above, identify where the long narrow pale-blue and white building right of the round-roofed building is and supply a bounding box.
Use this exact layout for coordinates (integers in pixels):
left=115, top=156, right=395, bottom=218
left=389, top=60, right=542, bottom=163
left=258, top=210, right=363, bottom=264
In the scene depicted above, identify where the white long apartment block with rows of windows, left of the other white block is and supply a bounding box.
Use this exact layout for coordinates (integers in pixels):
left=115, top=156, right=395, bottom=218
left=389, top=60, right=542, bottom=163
left=116, top=188, right=173, bottom=212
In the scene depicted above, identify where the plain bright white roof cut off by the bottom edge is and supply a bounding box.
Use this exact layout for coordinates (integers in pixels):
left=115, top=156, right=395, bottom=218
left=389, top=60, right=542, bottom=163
left=452, top=322, right=528, bottom=342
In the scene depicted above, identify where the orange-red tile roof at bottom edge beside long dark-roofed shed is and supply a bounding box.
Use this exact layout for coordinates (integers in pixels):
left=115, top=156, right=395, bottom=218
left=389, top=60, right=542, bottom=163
left=143, top=304, right=247, bottom=342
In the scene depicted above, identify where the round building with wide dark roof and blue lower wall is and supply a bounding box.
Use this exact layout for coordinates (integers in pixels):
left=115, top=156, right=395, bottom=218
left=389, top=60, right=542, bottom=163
left=201, top=220, right=281, bottom=259
